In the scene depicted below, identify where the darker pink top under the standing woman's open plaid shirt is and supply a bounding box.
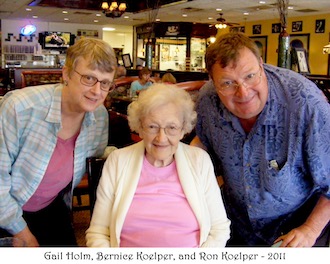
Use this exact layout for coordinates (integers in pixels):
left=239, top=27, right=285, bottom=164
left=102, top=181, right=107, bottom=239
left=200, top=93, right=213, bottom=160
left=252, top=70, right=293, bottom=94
left=23, top=133, right=79, bottom=212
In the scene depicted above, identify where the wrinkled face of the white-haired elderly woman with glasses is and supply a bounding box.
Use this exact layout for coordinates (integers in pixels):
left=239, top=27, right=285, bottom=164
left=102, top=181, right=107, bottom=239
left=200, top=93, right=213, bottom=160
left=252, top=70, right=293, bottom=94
left=140, top=103, right=184, bottom=167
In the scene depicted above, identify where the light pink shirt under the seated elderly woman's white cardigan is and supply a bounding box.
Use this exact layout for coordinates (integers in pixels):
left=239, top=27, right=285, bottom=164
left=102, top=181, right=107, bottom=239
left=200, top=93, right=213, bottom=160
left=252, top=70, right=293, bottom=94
left=120, top=158, right=200, bottom=247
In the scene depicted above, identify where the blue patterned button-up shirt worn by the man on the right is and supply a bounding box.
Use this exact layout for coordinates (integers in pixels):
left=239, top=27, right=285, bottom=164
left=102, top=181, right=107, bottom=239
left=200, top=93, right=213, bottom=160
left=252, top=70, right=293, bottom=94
left=196, top=65, right=330, bottom=244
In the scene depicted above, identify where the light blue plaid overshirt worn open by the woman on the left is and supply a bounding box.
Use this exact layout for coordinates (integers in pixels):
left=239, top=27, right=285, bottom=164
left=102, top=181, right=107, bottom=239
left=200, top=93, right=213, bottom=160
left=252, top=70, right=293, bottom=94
left=0, top=84, right=108, bottom=234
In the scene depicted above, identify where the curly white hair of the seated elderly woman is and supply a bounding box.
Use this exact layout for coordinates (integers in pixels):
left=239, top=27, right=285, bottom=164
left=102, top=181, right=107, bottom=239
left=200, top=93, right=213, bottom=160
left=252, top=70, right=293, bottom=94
left=127, top=83, right=197, bottom=134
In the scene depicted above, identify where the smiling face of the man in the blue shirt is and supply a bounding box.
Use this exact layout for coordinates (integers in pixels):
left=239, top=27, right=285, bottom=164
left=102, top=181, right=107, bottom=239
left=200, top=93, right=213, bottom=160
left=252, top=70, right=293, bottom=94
left=212, top=48, right=268, bottom=119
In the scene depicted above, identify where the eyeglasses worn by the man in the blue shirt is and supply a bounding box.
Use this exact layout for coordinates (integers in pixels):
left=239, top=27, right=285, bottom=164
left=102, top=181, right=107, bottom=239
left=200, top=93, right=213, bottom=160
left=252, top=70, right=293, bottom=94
left=218, top=66, right=261, bottom=96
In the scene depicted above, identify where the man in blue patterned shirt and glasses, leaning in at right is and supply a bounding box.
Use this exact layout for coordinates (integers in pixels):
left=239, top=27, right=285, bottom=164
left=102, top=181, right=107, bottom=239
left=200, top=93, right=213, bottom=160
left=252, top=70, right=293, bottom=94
left=192, top=33, right=330, bottom=247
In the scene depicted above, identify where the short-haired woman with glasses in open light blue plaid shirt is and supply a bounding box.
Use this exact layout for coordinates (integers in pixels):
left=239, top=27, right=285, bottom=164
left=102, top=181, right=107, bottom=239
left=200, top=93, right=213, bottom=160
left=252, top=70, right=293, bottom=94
left=0, top=38, right=117, bottom=247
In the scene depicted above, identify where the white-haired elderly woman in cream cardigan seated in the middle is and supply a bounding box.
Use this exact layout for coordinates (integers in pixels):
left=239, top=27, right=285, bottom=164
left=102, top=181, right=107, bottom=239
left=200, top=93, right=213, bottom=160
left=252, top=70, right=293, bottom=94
left=86, top=83, right=230, bottom=247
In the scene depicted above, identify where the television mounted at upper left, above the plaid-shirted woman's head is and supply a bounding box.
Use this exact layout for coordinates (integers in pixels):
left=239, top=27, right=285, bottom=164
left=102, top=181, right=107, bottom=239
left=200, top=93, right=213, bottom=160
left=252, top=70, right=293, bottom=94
left=39, top=31, right=74, bottom=49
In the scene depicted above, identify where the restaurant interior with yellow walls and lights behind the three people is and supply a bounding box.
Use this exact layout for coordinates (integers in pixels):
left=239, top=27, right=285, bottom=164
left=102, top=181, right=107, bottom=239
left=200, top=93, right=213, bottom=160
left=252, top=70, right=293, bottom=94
left=0, top=0, right=330, bottom=246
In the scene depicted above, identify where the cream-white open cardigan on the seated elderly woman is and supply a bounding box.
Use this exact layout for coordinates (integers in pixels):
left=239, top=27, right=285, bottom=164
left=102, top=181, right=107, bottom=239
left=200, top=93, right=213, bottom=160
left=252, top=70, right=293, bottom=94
left=86, top=140, right=230, bottom=247
